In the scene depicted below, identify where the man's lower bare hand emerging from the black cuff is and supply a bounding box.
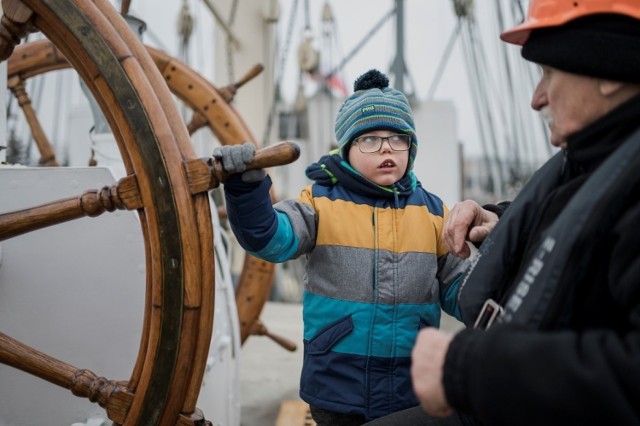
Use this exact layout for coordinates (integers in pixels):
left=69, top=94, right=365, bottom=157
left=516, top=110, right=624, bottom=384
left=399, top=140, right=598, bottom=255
left=411, top=327, right=453, bottom=417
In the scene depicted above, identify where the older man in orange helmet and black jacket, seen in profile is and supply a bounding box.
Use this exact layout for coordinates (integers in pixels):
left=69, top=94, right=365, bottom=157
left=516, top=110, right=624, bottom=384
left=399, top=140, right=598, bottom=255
left=364, top=0, right=640, bottom=426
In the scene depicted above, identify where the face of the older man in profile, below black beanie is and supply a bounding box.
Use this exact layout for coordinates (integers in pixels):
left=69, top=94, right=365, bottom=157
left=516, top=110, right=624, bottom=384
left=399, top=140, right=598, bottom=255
left=531, top=65, right=609, bottom=148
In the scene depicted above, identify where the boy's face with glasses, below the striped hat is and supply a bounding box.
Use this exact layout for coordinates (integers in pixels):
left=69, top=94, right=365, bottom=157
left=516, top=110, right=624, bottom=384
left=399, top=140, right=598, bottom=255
left=349, top=130, right=409, bottom=186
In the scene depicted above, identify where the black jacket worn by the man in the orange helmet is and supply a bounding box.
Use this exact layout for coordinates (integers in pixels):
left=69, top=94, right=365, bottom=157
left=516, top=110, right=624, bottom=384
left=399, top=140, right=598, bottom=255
left=443, top=92, right=640, bottom=426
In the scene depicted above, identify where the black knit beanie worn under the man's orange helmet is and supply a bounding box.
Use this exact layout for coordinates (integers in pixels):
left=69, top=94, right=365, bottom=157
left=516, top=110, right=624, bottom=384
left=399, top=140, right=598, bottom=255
left=522, top=14, right=640, bottom=83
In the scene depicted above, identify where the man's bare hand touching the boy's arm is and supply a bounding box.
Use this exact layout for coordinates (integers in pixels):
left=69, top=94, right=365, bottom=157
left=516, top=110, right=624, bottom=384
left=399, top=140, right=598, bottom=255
left=442, top=200, right=498, bottom=258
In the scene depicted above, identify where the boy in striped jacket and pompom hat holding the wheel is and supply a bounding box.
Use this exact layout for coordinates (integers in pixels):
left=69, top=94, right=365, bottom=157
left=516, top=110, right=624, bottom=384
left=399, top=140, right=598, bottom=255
left=214, top=70, right=466, bottom=426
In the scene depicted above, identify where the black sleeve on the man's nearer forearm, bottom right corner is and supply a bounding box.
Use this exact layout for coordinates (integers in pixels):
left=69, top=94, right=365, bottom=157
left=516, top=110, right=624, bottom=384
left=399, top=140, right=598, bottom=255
left=443, top=225, right=640, bottom=426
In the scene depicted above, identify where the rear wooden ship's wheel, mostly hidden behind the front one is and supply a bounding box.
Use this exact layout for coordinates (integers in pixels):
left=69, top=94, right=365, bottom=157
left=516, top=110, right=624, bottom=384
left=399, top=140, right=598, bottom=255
left=7, top=40, right=288, bottom=350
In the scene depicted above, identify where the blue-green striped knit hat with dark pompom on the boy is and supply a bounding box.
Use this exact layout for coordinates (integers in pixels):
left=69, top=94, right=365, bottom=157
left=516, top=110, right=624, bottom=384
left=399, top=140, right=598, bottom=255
left=336, top=69, right=418, bottom=171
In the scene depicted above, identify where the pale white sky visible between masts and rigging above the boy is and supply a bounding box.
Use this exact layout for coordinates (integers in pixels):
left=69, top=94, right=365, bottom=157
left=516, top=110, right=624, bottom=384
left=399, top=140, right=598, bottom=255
left=113, top=0, right=547, bottom=161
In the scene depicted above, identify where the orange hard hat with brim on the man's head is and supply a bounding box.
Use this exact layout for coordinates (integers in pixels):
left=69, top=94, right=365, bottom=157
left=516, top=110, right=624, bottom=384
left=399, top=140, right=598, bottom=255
left=500, top=0, right=640, bottom=46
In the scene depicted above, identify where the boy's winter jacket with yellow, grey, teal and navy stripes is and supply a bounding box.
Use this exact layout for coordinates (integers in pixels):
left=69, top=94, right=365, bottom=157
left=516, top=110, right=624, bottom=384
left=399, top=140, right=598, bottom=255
left=225, top=153, right=466, bottom=419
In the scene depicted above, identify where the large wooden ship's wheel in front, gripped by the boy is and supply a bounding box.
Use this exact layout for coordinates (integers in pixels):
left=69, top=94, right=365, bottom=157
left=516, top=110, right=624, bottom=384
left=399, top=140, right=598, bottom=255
left=0, top=0, right=298, bottom=425
